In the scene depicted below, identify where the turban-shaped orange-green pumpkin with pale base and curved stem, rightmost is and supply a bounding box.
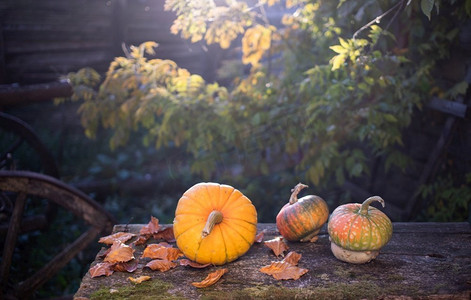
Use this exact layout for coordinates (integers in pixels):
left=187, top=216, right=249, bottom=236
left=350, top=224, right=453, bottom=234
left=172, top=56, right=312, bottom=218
left=327, top=196, right=393, bottom=263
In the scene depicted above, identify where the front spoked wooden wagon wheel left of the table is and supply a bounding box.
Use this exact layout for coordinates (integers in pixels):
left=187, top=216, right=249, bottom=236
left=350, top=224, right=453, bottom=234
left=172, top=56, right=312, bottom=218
left=0, top=171, right=115, bottom=299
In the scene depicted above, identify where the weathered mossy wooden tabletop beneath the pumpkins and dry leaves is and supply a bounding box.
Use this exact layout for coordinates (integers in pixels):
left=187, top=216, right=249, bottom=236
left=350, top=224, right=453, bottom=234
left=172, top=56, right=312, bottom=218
left=75, top=223, right=471, bottom=299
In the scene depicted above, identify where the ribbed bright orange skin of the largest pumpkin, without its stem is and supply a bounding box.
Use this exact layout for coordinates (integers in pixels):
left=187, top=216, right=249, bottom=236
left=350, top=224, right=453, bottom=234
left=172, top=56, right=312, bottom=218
left=173, top=183, right=257, bottom=265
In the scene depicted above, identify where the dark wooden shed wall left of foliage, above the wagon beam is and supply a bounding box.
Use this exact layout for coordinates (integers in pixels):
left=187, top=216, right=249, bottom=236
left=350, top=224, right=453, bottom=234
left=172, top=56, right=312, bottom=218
left=0, top=0, right=221, bottom=84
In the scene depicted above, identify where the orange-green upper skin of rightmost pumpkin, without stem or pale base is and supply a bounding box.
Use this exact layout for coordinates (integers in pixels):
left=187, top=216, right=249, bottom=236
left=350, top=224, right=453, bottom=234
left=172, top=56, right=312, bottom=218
left=327, top=203, right=393, bottom=251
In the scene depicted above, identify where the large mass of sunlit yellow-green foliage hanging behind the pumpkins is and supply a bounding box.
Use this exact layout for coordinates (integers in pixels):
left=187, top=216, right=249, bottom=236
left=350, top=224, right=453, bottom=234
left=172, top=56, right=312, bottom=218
left=63, top=0, right=470, bottom=218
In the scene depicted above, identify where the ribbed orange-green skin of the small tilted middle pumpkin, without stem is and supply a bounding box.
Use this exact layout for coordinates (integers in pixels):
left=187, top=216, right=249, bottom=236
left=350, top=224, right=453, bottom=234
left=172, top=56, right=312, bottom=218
left=276, top=195, right=329, bottom=242
